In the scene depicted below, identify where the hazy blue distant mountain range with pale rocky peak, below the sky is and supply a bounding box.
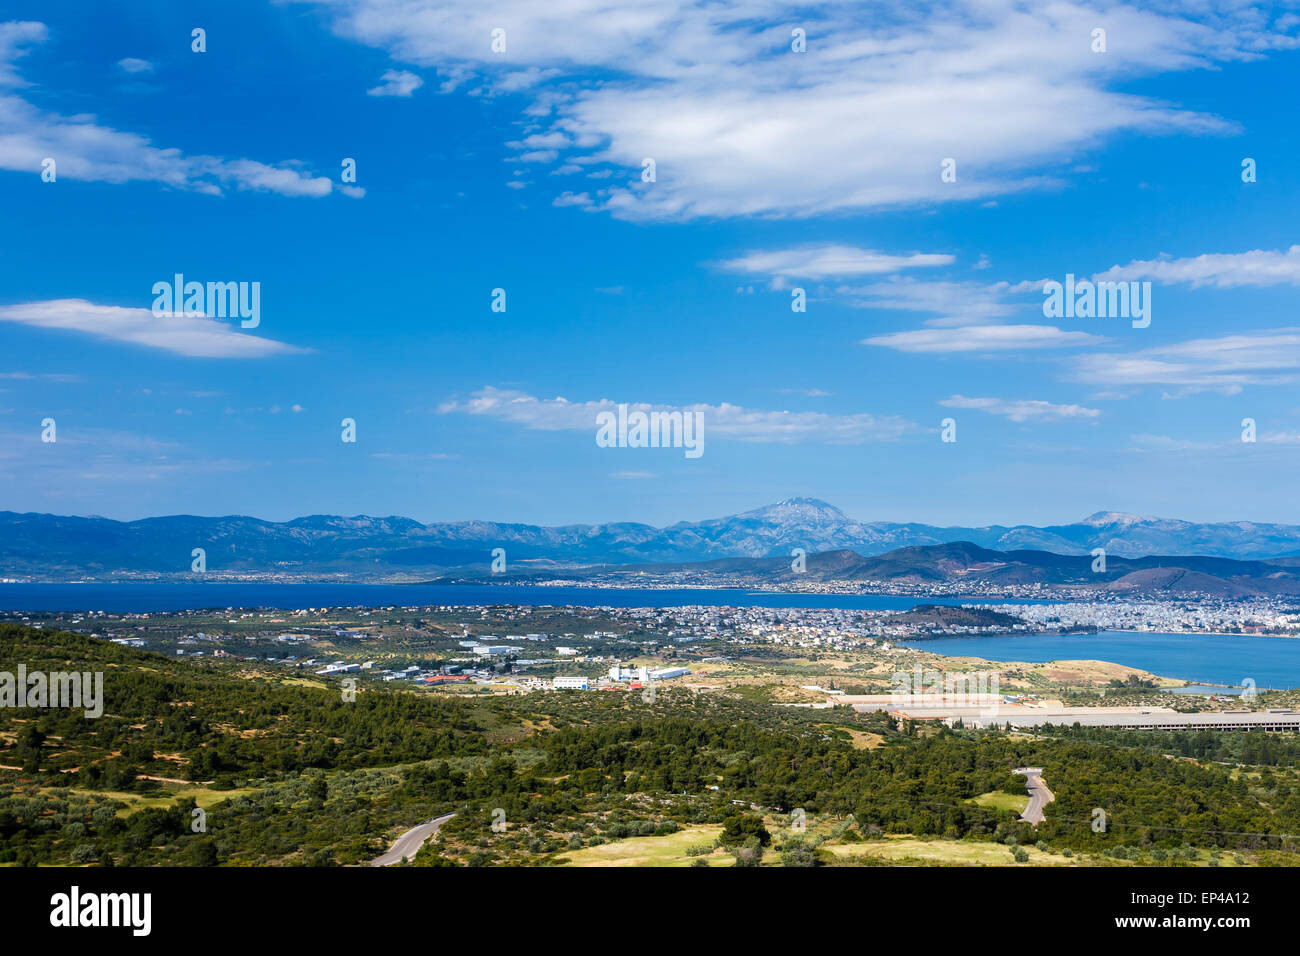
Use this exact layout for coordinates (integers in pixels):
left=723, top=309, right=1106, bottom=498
left=0, top=498, right=1300, bottom=580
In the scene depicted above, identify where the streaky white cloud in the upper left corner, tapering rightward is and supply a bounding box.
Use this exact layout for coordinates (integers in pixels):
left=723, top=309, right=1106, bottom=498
left=0, top=22, right=333, bottom=196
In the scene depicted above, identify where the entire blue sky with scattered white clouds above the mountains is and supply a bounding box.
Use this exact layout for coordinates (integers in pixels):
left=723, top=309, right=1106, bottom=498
left=0, top=0, right=1300, bottom=524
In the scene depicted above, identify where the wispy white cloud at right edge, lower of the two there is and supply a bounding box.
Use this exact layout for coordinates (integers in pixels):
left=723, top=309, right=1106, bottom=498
left=1075, top=328, right=1300, bottom=394
